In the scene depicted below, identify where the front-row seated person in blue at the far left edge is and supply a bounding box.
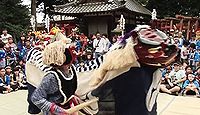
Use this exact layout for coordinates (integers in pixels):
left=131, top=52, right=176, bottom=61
left=0, top=67, right=12, bottom=93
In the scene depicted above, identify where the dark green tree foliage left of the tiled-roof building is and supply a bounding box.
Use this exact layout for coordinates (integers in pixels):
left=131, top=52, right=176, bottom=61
left=0, top=0, right=30, bottom=38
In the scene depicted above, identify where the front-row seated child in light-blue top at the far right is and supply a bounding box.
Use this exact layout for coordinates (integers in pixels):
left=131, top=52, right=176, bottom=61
left=183, top=74, right=200, bottom=95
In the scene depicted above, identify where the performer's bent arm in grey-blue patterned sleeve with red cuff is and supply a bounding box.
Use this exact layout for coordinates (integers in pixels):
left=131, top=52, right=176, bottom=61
left=31, top=74, right=65, bottom=115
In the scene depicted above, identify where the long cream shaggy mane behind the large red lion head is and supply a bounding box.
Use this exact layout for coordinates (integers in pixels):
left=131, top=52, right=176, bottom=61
left=90, top=39, right=140, bottom=86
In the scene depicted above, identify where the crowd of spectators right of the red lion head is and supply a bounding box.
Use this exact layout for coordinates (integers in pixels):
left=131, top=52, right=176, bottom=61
left=160, top=30, right=200, bottom=97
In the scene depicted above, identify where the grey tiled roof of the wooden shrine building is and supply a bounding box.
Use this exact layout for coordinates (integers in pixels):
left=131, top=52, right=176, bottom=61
left=55, top=0, right=151, bottom=15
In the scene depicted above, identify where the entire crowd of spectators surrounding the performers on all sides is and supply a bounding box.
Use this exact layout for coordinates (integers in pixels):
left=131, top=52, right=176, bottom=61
left=0, top=26, right=200, bottom=95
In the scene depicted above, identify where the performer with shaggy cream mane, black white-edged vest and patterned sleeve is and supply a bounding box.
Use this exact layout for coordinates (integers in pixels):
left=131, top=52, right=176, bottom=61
left=31, top=41, right=77, bottom=115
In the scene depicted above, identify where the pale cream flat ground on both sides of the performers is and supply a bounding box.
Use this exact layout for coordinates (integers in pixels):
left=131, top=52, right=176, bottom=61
left=0, top=90, right=200, bottom=115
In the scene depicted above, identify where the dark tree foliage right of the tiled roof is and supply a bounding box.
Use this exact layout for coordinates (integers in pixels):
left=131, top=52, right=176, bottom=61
left=146, top=0, right=200, bottom=17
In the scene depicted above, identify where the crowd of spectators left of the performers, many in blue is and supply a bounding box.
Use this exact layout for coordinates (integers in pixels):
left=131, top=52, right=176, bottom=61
left=0, top=29, right=28, bottom=93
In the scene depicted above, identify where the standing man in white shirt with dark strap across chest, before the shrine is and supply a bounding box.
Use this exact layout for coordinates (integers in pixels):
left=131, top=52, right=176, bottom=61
left=93, top=33, right=105, bottom=58
